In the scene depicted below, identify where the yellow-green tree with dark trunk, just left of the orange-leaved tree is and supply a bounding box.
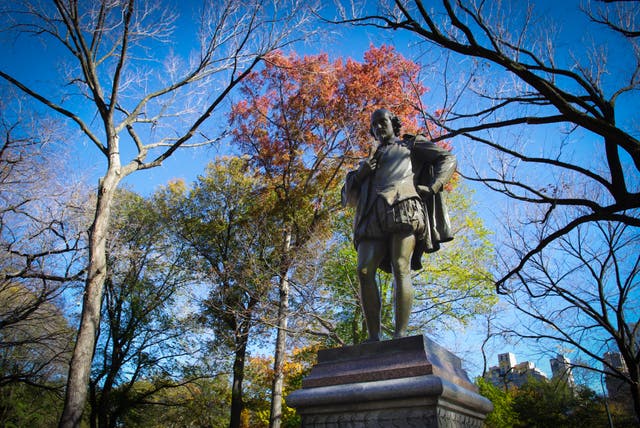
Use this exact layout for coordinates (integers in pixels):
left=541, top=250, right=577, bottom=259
left=156, top=157, right=279, bottom=427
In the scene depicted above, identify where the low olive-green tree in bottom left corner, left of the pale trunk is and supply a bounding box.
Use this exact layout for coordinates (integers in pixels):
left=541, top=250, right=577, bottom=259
left=0, top=282, right=73, bottom=428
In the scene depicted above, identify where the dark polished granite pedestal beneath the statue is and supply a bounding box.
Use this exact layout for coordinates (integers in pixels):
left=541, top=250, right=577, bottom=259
left=287, top=336, right=492, bottom=428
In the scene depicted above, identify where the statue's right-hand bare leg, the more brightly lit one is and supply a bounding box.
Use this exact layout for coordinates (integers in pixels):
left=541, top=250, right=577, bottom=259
left=391, top=234, right=416, bottom=338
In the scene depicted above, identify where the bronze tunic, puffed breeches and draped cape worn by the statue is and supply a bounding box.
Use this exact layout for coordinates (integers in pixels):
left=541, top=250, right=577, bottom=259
left=342, top=135, right=456, bottom=272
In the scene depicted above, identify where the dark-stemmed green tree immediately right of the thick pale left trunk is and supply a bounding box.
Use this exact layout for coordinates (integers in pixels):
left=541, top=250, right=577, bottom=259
left=89, top=190, right=201, bottom=428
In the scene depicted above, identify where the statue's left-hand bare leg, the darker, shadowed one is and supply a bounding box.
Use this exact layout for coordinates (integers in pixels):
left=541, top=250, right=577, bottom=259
left=358, top=239, right=386, bottom=341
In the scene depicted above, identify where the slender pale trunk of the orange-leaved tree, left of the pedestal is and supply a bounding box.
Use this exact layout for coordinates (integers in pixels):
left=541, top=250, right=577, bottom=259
left=269, top=230, right=291, bottom=428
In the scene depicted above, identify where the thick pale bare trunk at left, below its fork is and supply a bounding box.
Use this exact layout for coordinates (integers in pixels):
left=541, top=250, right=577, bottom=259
left=59, top=167, right=121, bottom=428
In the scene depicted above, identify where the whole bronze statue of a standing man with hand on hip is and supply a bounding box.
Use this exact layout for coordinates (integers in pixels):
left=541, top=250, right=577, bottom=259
left=342, top=109, right=456, bottom=341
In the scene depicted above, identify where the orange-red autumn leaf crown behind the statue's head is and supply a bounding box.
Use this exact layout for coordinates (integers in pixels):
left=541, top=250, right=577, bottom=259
left=229, top=46, right=427, bottom=194
